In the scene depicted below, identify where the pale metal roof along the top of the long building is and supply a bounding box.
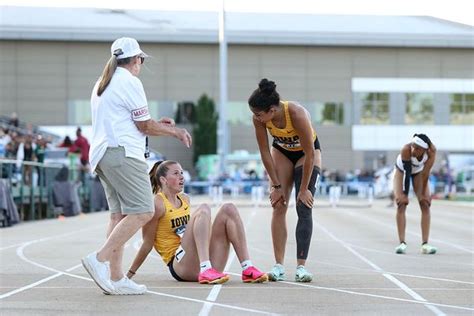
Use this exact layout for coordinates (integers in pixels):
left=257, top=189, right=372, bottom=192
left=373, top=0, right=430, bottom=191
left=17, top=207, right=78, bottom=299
left=0, top=6, right=474, bottom=48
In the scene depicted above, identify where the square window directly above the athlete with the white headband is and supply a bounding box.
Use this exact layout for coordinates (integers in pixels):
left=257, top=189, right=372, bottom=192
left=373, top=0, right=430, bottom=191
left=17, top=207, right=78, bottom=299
left=405, top=93, right=434, bottom=125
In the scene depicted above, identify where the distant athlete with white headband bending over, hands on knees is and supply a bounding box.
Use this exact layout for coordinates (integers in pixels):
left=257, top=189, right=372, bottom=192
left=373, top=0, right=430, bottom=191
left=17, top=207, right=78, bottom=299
left=393, top=134, right=436, bottom=254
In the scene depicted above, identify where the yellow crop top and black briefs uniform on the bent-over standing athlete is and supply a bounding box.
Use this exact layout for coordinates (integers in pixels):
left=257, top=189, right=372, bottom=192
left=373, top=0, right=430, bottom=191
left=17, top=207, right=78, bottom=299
left=266, top=101, right=321, bottom=165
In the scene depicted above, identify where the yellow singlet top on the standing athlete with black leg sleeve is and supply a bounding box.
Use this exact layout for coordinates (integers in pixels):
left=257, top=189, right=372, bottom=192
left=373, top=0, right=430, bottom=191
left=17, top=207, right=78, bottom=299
left=266, top=101, right=317, bottom=151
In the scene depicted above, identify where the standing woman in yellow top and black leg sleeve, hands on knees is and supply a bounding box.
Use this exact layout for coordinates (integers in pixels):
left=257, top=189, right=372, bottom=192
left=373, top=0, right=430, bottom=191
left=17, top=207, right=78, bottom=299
left=248, top=79, right=321, bottom=282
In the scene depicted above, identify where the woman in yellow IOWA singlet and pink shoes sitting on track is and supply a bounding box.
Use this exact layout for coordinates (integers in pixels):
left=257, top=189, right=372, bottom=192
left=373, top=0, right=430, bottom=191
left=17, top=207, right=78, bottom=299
left=128, top=160, right=268, bottom=284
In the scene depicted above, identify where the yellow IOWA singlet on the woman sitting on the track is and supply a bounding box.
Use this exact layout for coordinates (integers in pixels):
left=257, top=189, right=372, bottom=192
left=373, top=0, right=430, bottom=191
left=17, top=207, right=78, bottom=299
left=154, top=192, right=191, bottom=264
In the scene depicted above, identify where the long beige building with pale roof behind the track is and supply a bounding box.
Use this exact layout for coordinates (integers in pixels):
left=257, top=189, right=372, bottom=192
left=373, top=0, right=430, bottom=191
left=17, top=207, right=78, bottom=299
left=0, top=7, right=474, bottom=170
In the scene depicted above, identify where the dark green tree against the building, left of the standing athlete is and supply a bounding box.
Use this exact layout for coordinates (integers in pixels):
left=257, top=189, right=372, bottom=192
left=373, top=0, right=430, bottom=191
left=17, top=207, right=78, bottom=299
left=193, top=94, right=218, bottom=163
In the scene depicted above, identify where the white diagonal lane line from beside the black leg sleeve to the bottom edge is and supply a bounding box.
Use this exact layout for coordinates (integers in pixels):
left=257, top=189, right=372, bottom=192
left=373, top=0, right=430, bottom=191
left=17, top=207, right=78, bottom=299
left=316, top=224, right=446, bottom=316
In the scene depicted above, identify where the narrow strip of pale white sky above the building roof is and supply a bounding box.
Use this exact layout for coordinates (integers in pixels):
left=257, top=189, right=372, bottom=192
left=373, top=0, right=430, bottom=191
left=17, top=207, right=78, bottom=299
left=0, top=0, right=474, bottom=26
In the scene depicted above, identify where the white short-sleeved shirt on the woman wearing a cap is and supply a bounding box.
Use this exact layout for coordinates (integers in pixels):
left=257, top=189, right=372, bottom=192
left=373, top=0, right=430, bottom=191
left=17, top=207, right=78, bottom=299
left=89, top=67, right=151, bottom=171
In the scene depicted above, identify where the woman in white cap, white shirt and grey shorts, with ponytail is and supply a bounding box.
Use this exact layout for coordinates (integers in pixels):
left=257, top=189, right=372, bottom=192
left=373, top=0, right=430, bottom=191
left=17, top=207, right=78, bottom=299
left=82, top=37, right=192, bottom=295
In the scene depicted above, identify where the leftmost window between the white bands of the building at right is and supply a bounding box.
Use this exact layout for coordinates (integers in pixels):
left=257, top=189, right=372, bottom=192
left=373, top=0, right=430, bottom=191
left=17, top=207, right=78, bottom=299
left=360, top=93, right=390, bottom=124
